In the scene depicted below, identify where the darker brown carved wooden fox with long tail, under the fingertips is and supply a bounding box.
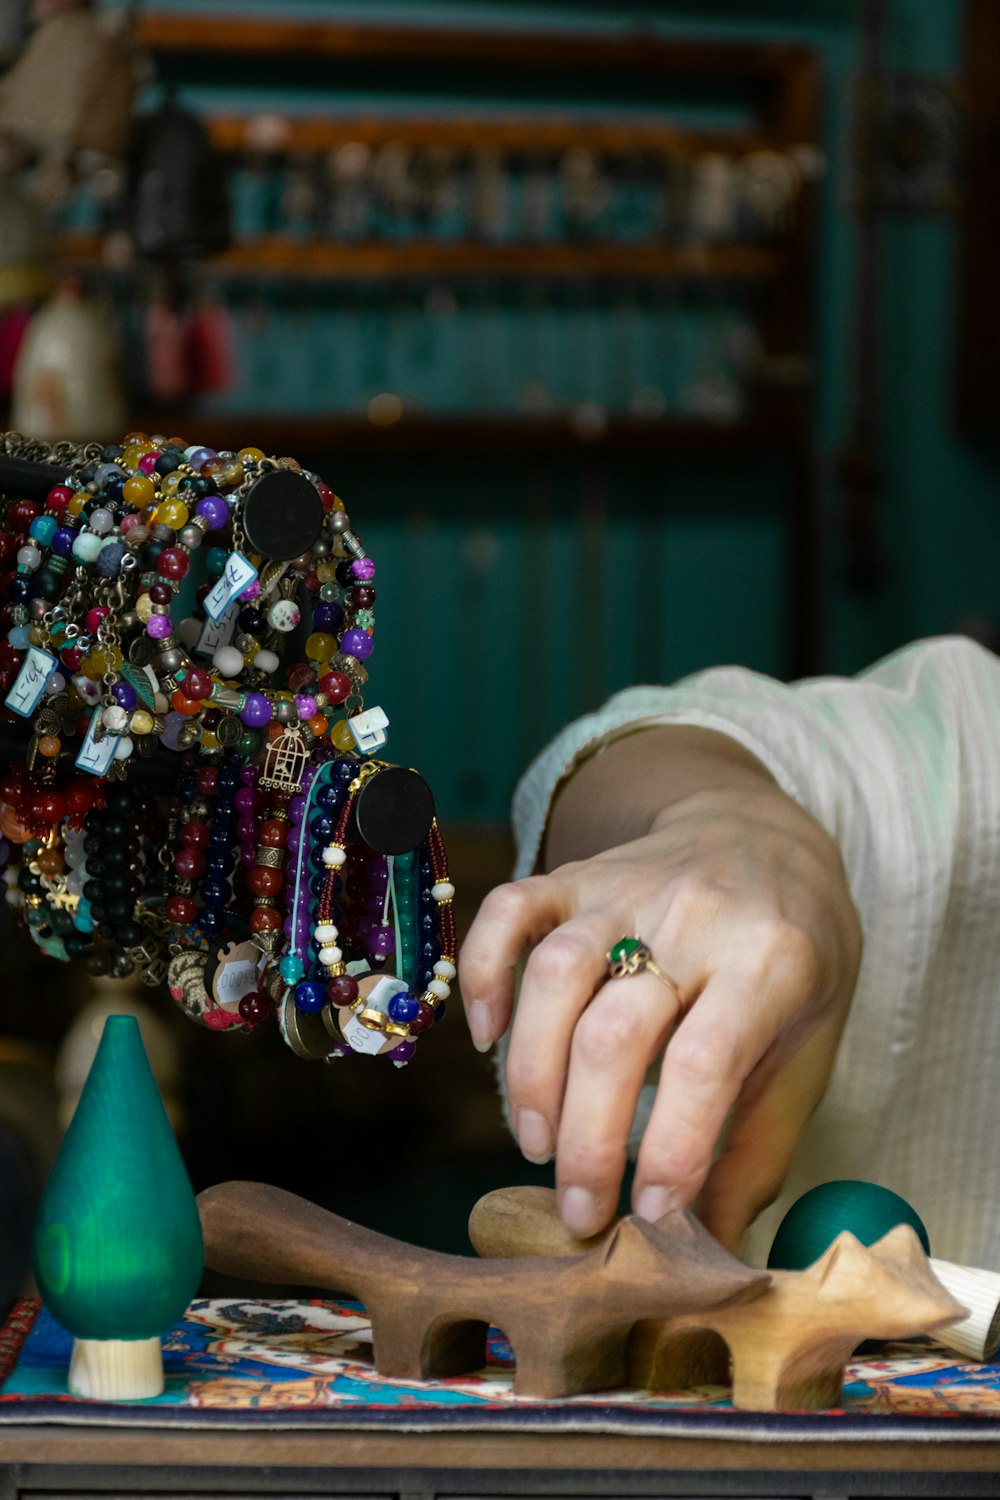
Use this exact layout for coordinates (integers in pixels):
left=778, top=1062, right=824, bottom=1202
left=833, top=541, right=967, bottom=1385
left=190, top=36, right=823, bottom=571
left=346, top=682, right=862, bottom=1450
left=198, top=1182, right=769, bottom=1397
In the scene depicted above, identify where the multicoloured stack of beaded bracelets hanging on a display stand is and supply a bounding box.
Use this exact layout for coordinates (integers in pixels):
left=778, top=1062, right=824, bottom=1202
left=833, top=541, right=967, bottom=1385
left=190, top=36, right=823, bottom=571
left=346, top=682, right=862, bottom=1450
left=0, top=432, right=456, bottom=1064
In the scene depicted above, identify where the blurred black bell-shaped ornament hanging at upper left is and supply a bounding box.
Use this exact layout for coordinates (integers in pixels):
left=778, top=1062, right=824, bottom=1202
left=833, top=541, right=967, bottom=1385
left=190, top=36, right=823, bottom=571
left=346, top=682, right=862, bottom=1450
left=126, top=92, right=229, bottom=261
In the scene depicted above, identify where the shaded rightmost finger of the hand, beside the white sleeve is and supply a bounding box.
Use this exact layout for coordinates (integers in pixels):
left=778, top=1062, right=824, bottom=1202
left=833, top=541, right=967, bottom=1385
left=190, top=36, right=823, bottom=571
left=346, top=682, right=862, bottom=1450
left=699, top=1019, right=840, bottom=1254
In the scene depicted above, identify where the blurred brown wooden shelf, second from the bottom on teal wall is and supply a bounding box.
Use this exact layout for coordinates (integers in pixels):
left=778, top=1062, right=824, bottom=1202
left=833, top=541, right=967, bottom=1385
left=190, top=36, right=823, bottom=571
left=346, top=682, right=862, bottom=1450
left=60, top=234, right=786, bottom=281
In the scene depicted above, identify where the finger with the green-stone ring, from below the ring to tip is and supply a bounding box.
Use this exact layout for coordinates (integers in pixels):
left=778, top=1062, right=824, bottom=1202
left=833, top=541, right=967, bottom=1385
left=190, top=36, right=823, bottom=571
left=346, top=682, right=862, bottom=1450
left=551, top=974, right=681, bottom=1238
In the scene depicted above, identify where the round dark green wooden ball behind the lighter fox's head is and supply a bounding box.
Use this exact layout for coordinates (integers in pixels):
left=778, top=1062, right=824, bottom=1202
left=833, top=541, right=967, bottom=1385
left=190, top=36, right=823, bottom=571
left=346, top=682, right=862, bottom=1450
left=768, top=1179, right=931, bottom=1271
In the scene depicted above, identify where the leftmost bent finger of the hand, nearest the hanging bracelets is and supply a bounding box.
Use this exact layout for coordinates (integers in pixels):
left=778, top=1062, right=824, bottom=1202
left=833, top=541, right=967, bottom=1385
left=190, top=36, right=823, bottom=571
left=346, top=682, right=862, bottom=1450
left=459, top=875, right=570, bottom=1052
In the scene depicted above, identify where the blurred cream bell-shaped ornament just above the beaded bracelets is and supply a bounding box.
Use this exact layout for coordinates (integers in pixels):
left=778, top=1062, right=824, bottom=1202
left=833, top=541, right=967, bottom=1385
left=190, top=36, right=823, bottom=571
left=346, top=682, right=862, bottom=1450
left=10, top=281, right=127, bottom=443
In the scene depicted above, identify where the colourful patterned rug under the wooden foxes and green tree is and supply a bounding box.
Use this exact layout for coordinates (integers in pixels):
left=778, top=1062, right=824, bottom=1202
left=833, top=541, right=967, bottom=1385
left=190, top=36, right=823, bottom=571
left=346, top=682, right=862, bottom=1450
left=0, top=1299, right=1000, bottom=1442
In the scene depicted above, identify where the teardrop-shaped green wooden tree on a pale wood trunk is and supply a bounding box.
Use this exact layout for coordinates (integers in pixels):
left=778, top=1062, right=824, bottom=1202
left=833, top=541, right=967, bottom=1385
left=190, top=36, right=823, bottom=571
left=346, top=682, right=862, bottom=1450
left=34, top=1016, right=202, bottom=1400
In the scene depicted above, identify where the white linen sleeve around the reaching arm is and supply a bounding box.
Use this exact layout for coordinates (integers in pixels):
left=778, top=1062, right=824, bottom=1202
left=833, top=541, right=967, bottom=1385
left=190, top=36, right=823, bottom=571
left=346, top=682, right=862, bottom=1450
left=513, top=638, right=1000, bottom=1266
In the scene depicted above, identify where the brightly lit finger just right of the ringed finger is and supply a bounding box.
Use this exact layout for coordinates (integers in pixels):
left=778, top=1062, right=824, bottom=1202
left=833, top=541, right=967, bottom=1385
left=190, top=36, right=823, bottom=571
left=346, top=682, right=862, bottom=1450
left=633, top=971, right=798, bottom=1220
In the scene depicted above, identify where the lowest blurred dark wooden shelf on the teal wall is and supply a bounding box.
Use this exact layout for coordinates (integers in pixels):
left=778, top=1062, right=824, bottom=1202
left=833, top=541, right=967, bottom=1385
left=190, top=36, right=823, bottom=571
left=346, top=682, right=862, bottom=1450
left=119, top=407, right=805, bottom=459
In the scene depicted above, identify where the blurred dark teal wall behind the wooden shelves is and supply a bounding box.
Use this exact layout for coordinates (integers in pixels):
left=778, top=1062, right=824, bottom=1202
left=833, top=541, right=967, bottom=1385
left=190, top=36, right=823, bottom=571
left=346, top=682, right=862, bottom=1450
left=103, top=0, right=1000, bottom=818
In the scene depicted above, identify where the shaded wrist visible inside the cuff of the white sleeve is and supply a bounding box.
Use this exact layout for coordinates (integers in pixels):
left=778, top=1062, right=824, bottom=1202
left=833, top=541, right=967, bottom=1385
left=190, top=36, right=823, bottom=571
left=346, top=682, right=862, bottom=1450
left=541, top=725, right=784, bottom=870
